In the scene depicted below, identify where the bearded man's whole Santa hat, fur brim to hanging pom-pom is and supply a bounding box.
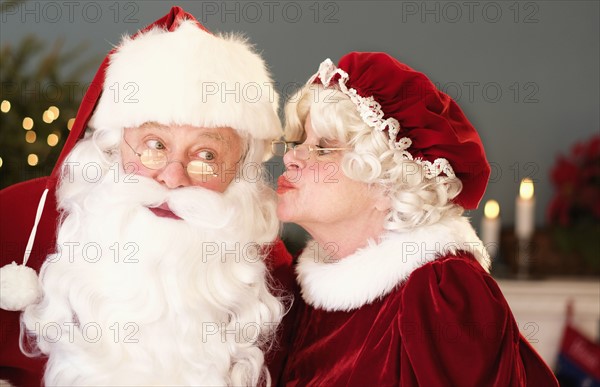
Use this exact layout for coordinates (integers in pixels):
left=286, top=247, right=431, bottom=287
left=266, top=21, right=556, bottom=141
left=0, top=7, right=283, bottom=310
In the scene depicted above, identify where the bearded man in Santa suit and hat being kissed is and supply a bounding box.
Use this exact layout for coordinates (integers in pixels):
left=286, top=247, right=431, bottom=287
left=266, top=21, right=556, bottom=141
left=0, top=7, right=290, bottom=385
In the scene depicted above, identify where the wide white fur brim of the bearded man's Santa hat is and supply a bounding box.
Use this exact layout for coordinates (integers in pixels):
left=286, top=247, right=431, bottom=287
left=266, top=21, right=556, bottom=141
left=89, top=21, right=283, bottom=140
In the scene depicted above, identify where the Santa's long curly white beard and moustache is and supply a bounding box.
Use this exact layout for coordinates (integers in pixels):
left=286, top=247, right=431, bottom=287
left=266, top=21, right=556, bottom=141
left=22, top=162, right=283, bottom=385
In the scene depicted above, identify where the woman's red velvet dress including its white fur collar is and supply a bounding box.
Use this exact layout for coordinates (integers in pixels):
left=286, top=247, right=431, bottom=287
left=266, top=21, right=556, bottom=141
left=280, top=218, right=557, bottom=387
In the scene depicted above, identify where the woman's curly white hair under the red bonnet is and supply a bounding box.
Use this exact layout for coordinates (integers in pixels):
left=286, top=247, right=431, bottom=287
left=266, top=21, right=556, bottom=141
left=285, top=84, right=464, bottom=231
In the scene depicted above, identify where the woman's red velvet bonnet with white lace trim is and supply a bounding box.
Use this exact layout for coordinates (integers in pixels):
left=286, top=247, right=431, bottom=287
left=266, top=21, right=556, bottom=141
left=308, top=52, right=490, bottom=209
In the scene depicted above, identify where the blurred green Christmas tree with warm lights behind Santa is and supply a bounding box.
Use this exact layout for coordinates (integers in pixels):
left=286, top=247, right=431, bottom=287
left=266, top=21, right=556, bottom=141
left=0, top=1, right=102, bottom=188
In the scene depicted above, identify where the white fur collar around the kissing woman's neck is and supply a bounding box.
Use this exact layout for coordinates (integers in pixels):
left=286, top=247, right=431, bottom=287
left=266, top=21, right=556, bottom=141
left=296, top=217, right=490, bottom=311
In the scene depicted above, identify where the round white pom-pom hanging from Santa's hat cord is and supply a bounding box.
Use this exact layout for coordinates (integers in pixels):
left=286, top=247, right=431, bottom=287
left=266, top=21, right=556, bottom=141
left=0, top=262, right=42, bottom=310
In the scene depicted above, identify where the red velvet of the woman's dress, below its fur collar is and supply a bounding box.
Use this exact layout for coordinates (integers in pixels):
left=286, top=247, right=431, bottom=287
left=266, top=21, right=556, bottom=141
left=280, top=254, right=558, bottom=387
